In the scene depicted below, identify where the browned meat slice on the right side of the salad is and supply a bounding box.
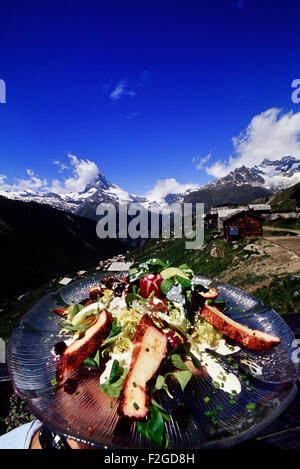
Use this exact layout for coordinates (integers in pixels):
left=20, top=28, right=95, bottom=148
left=201, top=305, right=280, bottom=352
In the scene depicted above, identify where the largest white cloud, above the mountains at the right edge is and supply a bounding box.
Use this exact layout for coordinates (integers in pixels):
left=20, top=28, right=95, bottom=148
left=206, top=108, right=300, bottom=178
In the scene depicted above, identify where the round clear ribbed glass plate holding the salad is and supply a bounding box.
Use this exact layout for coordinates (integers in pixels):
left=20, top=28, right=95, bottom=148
left=7, top=272, right=300, bottom=449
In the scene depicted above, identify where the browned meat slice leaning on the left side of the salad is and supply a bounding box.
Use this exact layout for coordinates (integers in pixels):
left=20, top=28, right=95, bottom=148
left=56, top=310, right=112, bottom=381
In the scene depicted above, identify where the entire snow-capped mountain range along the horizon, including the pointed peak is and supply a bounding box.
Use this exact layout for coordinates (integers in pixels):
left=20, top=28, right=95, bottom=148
left=0, top=156, right=300, bottom=220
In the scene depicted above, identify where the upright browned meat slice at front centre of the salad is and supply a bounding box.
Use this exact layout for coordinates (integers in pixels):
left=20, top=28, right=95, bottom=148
left=118, top=315, right=168, bottom=420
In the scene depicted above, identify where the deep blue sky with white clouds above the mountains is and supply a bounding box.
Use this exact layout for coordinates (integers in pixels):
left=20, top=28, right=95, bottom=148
left=0, top=0, right=300, bottom=194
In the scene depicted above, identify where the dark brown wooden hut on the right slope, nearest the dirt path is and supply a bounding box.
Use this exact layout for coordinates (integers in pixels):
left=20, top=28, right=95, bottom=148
left=220, top=210, right=263, bottom=242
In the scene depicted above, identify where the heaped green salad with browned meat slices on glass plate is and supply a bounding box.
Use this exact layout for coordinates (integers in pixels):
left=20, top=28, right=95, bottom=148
left=52, top=258, right=280, bottom=447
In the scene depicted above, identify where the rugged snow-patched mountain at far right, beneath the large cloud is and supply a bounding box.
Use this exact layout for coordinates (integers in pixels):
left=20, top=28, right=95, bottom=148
left=205, top=156, right=300, bottom=192
